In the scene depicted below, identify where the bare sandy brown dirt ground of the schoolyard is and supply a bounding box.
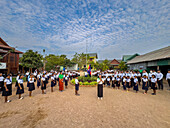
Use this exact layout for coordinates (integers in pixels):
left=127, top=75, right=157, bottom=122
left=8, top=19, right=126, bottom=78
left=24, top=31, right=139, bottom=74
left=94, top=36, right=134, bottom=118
left=0, top=79, right=170, bottom=128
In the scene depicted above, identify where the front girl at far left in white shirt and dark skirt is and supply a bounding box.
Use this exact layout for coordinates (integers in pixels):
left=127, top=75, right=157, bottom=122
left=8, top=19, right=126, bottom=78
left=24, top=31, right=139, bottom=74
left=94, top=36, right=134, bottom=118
left=2, top=75, right=12, bottom=103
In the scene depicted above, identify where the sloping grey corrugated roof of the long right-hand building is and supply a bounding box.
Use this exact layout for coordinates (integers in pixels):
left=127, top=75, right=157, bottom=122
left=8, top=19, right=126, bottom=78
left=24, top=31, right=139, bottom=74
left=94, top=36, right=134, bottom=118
left=127, top=46, right=170, bottom=64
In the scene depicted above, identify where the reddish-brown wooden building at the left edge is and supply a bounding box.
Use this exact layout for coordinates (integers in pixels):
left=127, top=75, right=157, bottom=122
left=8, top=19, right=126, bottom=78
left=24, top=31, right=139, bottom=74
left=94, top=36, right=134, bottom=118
left=0, top=38, right=22, bottom=74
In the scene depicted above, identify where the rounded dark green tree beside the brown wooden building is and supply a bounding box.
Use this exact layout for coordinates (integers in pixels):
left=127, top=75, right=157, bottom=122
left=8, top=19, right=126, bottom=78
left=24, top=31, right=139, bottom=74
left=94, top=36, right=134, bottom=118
left=20, top=50, right=43, bottom=72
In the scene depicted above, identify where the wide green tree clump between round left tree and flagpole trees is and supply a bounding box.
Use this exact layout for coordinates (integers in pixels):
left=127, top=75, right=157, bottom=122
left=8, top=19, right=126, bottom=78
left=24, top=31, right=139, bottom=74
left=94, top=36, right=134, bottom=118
left=45, top=54, right=74, bottom=71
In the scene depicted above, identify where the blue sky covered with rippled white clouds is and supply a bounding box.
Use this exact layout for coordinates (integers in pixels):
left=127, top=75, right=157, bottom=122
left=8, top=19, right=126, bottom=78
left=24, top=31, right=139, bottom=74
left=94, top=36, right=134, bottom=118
left=0, top=0, right=170, bottom=59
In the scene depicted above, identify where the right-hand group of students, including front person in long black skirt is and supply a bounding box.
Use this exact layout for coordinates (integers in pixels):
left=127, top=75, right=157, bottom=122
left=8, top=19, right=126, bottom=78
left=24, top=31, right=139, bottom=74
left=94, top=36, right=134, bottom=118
left=96, top=70, right=170, bottom=99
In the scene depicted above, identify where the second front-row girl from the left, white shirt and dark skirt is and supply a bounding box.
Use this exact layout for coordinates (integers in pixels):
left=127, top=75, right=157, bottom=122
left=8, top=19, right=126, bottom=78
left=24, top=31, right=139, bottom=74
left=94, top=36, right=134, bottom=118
left=16, top=75, right=24, bottom=100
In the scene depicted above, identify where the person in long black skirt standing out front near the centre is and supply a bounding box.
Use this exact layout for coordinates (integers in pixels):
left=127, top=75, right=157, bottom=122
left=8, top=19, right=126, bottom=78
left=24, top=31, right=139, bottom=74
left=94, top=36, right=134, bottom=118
left=97, top=75, right=103, bottom=100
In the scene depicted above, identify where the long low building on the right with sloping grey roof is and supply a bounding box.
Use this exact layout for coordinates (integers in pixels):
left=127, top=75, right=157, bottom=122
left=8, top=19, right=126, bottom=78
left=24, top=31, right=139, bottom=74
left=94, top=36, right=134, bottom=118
left=127, top=46, right=170, bottom=74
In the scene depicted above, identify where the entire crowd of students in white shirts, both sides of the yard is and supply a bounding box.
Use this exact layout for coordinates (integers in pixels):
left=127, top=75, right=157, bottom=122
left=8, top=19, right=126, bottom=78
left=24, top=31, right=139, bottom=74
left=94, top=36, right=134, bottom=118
left=0, top=70, right=170, bottom=102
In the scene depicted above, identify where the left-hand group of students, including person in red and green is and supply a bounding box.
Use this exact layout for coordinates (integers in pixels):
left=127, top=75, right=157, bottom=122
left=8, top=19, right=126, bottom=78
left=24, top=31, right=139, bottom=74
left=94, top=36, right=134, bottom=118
left=0, top=70, right=80, bottom=103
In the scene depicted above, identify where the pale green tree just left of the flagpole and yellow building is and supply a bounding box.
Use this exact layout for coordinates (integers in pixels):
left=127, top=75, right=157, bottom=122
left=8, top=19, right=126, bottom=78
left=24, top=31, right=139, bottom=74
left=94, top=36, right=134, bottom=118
left=71, top=53, right=89, bottom=69
